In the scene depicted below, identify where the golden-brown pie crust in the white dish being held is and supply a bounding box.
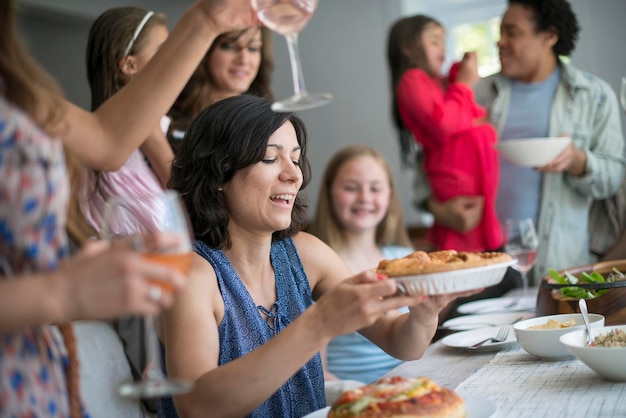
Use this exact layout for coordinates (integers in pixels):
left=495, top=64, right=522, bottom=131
left=376, top=250, right=511, bottom=277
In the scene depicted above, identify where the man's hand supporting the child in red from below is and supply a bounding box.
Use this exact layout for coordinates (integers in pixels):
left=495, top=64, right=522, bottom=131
left=428, top=196, right=484, bottom=233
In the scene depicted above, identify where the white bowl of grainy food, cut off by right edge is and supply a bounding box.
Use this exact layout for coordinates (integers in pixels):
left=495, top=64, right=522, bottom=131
left=560, top=325, right=626, bottom=382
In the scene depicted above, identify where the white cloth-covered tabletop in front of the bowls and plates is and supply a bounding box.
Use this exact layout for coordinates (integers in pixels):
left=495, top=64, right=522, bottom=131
left=384, top=290, right=626, bottom=418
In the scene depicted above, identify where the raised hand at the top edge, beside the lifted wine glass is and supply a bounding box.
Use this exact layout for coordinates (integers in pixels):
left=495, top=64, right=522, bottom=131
left=196, top=0, right=260, bottom=33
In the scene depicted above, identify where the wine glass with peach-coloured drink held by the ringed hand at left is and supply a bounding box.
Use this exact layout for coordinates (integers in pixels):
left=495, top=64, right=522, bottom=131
left=103, top=190, right=192, bottom=398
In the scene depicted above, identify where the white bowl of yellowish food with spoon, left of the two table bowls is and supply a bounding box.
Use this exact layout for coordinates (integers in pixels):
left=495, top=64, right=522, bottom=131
left=513, top=313, right=604, bottom=360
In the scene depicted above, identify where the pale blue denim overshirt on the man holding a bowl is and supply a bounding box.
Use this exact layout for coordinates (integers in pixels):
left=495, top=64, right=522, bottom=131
left=415, top=63, right=626, bottom=282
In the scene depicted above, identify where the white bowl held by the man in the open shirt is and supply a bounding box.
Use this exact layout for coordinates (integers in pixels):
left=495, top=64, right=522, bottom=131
left=496, top=137, right=571, bottom=167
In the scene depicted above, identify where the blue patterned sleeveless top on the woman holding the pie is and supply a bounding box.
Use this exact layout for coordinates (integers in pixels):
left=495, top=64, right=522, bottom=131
left=159, top=238, right=326, bottom=418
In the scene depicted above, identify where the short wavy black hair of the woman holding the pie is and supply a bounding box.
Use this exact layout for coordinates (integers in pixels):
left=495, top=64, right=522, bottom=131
left=169, top=94, right=311, bottom=249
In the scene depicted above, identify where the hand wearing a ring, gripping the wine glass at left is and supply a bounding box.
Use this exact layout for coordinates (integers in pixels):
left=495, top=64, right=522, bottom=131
left=54, top=237, right=186, bottom=319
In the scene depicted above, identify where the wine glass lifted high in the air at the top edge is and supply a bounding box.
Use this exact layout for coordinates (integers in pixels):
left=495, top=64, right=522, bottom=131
left=251, top=0, right=333, bottom=112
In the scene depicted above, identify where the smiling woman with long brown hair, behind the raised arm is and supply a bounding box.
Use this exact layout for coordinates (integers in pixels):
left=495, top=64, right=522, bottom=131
left=168, top=27, right=274, bottom=151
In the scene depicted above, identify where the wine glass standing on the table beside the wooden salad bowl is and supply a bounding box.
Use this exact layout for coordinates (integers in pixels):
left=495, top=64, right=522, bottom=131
left=503, top=218, right=539, bottom=302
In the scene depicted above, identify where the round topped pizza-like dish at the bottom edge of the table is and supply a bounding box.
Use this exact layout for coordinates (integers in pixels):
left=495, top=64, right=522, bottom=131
left=328, top=376, right=465, bottom=418
